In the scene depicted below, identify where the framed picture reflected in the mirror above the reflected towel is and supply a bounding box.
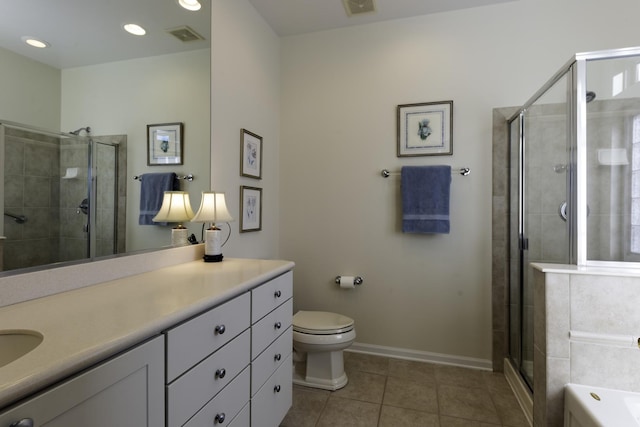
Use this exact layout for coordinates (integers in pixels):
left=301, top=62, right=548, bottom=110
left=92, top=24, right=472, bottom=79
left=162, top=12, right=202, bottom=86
left=147, top=123, right=184, bottom=166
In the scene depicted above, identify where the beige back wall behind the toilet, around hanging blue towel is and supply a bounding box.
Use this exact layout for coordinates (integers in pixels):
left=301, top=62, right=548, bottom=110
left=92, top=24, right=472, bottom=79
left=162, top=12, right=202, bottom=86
left=276, top=0, right=640, bottom=366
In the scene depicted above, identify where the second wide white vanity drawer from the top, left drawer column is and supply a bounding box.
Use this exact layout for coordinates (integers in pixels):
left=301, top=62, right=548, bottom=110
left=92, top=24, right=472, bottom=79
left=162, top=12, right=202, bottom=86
left=167, top=330, right=250, bottom=427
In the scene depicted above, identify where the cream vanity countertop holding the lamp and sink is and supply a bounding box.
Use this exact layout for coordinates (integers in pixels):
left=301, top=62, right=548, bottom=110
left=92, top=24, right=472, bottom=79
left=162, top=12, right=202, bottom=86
left=0, top=258, right=294, bottom=408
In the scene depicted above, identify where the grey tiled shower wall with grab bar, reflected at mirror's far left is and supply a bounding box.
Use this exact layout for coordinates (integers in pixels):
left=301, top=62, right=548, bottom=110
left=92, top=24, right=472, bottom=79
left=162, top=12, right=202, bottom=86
left=3, top=128, right=60, bottom=270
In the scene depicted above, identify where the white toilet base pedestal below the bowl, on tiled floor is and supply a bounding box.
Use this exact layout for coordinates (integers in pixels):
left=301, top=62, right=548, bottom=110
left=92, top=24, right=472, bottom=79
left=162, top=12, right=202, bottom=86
left=293, top=351, right=349, bottom=391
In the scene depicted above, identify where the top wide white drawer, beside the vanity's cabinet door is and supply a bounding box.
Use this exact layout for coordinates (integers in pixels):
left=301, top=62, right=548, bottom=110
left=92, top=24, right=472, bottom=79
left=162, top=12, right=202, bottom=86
left=167, top=293, right=251, bottom=383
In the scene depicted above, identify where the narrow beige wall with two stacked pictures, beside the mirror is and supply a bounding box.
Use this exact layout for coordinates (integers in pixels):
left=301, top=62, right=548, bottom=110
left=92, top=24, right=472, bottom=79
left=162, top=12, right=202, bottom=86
left=211, top=0, right=282, bottom=258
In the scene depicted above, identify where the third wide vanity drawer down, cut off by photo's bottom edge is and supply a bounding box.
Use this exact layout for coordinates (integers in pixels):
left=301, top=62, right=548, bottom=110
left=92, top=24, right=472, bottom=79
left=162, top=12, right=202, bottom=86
left=184, top=367, right=250, bottom=427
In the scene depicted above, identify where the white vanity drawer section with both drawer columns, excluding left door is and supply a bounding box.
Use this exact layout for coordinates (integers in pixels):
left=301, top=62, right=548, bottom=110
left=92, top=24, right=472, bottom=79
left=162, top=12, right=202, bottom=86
left=166, top=272, right=293, bottom=427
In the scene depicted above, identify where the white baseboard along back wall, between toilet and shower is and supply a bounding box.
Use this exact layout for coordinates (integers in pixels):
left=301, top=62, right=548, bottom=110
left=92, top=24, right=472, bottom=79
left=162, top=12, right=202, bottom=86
left=345, top=342, right=492, bottom=371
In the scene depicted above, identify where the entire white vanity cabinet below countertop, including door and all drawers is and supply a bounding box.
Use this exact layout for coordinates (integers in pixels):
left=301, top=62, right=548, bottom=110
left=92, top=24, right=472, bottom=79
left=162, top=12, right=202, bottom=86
left=0, top=260, right=293, bottom=427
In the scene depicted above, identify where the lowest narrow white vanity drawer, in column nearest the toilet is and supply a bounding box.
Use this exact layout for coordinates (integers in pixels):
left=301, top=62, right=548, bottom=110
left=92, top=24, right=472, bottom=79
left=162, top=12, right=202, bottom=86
left=251, top=356, right=292, bottom=427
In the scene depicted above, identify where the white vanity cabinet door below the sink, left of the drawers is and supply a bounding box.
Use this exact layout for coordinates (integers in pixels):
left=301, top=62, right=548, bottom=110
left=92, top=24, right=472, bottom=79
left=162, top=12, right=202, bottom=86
left=0, top=337, right=164, bottom=427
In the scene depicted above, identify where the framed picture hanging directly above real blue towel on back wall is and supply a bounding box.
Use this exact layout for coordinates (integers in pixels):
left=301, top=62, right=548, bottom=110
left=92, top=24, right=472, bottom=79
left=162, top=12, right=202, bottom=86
left=398, top=101, right=453, bottom=157
